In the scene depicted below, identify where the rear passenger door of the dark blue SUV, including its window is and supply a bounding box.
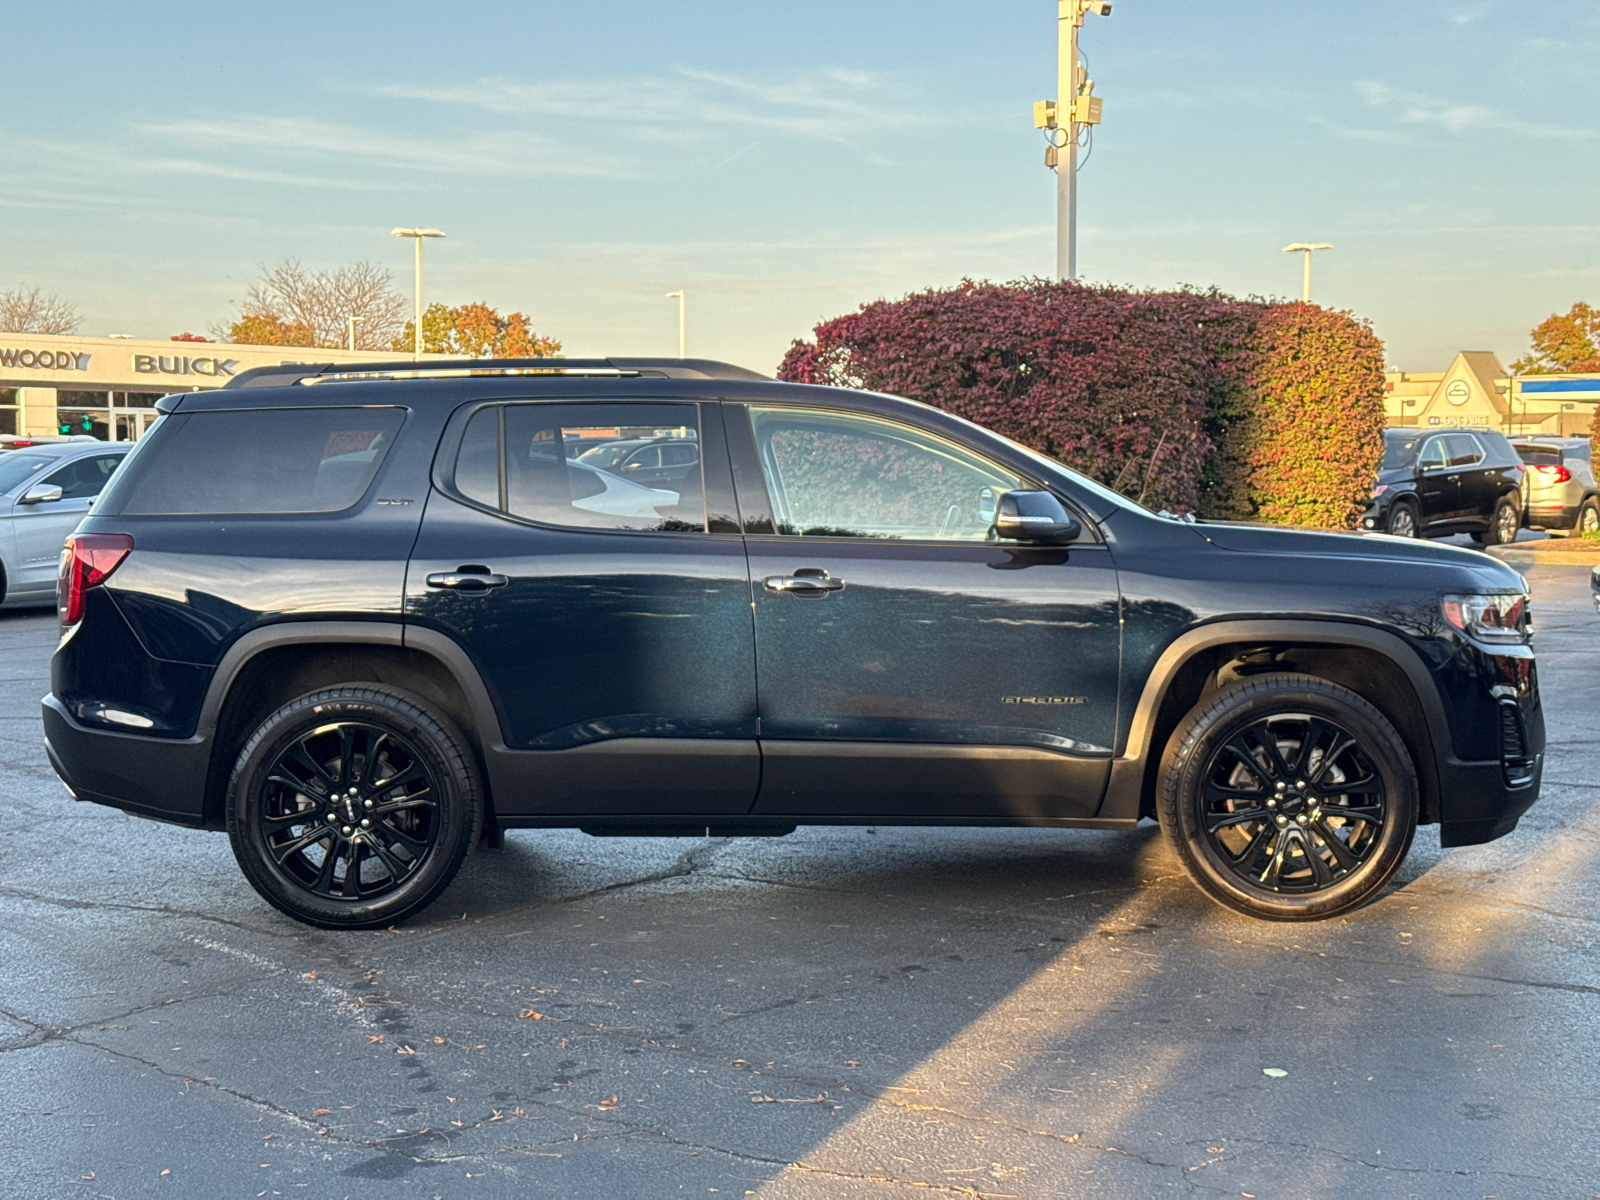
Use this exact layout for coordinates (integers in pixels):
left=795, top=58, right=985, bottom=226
left=406, top=402, right=760, bottom=816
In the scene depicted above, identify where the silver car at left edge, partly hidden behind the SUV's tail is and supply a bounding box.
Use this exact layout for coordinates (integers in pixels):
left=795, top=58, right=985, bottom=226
left=0, top=438, right=133, bottom=608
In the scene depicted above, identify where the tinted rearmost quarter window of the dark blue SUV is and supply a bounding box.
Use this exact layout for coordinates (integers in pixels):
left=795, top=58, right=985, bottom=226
left=104, top=408, right=405, bottom=517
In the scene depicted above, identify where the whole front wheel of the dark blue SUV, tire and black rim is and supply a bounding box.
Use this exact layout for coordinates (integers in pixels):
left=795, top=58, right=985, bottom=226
left=1157, top=674, right=1418, bottom=922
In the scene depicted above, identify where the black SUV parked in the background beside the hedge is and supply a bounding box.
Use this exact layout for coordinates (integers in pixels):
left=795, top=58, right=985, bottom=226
left=1362, top=427, right=1525, bottom=546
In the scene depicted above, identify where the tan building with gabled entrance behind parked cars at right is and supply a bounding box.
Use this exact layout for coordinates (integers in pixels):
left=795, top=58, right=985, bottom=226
left=1384, top=350, right=1600, bottom=437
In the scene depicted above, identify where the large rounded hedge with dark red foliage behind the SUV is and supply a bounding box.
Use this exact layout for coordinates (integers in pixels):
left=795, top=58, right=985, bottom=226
left=779, top=280, right=1384, bottom=528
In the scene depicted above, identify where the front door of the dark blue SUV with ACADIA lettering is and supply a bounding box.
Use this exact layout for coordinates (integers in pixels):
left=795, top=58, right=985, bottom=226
left=726, top=405, right=1118, bottom=819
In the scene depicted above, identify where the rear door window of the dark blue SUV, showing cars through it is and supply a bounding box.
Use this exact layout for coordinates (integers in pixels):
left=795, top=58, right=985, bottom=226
left=454, top=403, right=706, bottom=533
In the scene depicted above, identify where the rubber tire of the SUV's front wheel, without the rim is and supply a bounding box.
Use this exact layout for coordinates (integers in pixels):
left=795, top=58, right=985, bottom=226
left=1160, top=675, right=1418, bottom=920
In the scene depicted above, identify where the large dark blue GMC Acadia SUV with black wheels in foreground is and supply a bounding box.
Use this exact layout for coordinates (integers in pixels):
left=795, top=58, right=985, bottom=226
left=43, top=360, right=1544, bottom=928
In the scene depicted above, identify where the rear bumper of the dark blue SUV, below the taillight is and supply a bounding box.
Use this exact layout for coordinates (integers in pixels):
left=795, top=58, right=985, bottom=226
left=43, top=696, right=211, bottom=826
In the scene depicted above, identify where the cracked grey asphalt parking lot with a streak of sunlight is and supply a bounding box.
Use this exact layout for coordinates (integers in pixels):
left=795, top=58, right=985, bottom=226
left=0, top=566, right=1600, bottom=1200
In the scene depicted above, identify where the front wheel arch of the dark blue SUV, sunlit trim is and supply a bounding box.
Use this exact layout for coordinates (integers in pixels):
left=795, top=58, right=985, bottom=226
left=1099, top=619, right=1450, bottom=824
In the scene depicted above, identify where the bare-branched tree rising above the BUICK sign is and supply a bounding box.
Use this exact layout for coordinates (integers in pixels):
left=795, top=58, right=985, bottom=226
left=213, top=259, right=406, bottom=350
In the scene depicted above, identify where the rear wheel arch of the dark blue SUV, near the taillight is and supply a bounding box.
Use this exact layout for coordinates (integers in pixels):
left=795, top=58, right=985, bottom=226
left=197, top=621, right=502, bottom=829
